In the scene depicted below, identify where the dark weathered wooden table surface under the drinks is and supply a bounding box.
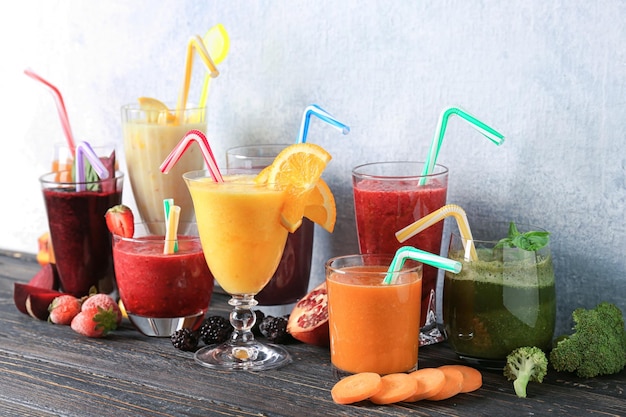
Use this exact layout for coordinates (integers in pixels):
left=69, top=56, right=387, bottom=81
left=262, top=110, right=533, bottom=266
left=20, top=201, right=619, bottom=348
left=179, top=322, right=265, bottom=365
left=0, top=251, right=626, bottom=417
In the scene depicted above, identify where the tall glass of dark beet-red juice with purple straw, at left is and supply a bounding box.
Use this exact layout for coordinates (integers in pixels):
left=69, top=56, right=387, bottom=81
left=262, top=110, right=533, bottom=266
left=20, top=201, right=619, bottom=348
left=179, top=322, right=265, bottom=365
left=39, top=171, right=124, bottom=297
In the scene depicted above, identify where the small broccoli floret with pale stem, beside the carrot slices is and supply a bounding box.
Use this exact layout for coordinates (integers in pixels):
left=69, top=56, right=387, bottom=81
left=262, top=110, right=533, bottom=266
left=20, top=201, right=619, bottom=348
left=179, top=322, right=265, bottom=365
left=504, top=346, right=548, bottom=398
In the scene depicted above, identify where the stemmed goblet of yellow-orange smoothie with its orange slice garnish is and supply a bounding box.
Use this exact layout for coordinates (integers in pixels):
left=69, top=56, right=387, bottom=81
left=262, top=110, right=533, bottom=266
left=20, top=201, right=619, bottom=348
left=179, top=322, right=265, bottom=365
left=162, top=132, right=334, bottom=371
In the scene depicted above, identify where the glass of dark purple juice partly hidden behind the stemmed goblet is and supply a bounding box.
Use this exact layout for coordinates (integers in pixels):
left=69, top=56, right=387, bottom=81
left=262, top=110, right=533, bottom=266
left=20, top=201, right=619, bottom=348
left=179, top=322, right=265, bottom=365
left=226, top=144, right=314, bottom=316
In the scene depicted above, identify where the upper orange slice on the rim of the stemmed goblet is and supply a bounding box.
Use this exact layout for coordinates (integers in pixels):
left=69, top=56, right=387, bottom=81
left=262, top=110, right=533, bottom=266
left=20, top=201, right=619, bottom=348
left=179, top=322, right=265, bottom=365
left=256, top=143, right=331, bottom=233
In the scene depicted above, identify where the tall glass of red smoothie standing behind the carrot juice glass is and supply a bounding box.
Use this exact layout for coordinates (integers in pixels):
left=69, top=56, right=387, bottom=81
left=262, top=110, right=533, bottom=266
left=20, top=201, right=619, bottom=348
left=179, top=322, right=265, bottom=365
left=352, top=161, right=448, bottom=346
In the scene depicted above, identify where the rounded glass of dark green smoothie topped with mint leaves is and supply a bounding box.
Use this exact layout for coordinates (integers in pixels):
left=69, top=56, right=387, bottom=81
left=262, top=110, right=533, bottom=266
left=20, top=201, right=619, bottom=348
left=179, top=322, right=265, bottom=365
left=443, top=223, right=556, bottom=369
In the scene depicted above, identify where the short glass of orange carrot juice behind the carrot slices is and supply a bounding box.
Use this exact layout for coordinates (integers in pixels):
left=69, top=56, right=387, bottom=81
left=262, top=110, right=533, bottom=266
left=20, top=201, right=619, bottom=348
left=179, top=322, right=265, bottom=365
left=326, top=254, right=422, bottom=376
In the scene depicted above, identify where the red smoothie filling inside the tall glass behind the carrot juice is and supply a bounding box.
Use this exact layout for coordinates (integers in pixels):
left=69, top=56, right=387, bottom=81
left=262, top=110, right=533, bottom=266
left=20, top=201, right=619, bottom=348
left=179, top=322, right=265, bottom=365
left=354, top=180, right=448, bottom=325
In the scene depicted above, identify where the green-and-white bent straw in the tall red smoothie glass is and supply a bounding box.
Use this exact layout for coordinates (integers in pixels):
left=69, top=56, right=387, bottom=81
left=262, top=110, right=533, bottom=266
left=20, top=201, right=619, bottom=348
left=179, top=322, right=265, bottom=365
left=420, top=107, right=504, bottom=185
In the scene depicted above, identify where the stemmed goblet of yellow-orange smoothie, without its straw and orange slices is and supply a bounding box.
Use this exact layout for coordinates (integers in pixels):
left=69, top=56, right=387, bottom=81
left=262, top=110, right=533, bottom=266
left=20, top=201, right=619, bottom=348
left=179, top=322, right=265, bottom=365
left=183, top=170, right=291, bottom=371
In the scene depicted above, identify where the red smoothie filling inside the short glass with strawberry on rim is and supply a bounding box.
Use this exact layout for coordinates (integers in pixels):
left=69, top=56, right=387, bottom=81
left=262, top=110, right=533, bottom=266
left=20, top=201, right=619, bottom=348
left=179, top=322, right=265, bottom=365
left=113, top=236, right=213, bottom=318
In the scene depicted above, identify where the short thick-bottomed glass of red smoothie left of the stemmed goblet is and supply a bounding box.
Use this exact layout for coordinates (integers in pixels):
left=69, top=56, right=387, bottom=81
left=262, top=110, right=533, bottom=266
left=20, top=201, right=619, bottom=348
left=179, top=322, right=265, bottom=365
left=113, top=222, right=213, bottom=337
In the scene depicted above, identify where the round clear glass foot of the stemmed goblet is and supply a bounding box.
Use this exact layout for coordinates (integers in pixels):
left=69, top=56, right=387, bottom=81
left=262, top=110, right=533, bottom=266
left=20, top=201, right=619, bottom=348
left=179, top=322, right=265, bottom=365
left=194, top=341, right=291, bottom=371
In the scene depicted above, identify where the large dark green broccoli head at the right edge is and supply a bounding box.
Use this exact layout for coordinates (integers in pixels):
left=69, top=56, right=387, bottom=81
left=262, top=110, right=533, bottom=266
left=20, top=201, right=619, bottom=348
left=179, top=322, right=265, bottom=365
left=550, top=302, right=626, bottom=378
